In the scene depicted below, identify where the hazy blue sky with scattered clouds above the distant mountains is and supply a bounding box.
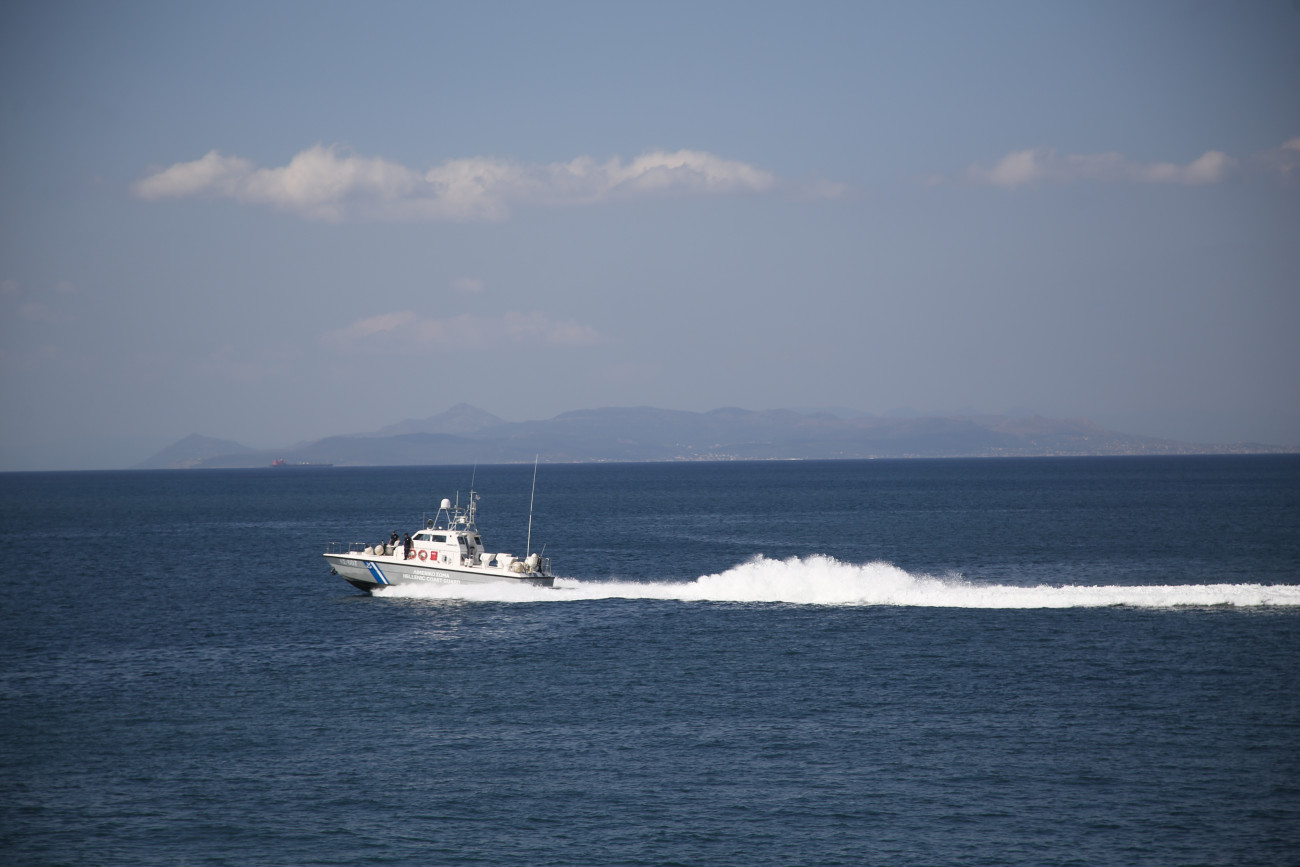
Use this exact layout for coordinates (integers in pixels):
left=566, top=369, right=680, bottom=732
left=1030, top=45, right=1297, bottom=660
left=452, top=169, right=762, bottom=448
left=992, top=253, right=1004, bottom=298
left=0, top=1, right=1300, bottom=469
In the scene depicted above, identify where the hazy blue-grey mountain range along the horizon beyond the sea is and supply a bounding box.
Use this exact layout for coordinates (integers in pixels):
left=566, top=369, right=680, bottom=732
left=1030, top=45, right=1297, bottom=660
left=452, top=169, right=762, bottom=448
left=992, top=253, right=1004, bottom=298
left=126, top=403, right=1287, bottom=469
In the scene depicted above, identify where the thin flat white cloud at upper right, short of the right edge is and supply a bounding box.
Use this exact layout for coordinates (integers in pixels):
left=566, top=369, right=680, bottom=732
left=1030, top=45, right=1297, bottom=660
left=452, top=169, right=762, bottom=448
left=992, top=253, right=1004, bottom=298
left=966, top=148, right=1236, bottom=190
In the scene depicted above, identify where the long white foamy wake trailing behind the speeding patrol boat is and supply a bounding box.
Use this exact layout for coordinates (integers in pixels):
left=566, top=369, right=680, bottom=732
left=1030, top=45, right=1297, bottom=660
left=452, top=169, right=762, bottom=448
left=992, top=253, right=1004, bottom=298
left=376, top=556, right=1300, bottom=608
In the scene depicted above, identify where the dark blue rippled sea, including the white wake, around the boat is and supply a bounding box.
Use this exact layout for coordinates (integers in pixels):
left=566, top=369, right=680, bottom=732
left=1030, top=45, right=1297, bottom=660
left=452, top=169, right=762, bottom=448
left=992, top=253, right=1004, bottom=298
left=0, top=456, right=1300, bottom=867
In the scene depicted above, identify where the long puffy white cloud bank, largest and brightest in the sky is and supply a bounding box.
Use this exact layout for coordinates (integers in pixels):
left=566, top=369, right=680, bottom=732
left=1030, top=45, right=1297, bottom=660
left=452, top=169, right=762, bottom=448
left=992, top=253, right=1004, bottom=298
left=131, top=144, right=790, bottom=221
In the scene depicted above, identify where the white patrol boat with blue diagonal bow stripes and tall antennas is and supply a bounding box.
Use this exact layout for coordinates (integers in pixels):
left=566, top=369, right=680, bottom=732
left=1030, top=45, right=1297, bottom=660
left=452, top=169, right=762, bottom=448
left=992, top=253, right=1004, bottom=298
left=325, top=491, right=555, bottom=593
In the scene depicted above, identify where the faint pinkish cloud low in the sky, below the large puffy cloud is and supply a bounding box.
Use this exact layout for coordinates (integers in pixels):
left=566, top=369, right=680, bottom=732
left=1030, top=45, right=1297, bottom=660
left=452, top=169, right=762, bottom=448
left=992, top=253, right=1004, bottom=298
left=324, top=311, right=607, bottom=354
